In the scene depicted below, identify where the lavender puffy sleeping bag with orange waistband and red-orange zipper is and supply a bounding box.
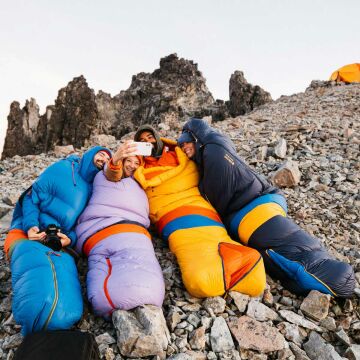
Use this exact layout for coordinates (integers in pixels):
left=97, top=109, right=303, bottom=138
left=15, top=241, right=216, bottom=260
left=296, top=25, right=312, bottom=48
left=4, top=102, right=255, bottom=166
left=76, top=171, right=165, bottom=318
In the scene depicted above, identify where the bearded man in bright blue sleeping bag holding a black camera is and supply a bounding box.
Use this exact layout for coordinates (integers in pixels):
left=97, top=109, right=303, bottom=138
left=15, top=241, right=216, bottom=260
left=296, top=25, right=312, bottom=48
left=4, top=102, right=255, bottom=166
left=4, top=146, right=111, bottom=334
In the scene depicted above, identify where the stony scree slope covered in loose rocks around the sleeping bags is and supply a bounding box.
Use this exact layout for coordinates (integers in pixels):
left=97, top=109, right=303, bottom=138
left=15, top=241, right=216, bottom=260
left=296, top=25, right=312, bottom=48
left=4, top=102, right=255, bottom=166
left=0, top=82, right=360, bottom=360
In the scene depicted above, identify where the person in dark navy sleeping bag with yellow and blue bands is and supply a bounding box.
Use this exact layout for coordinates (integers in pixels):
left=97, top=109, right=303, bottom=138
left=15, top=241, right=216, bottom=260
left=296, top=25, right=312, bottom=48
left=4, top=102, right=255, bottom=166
left=178, top=119, right=355, bottom=297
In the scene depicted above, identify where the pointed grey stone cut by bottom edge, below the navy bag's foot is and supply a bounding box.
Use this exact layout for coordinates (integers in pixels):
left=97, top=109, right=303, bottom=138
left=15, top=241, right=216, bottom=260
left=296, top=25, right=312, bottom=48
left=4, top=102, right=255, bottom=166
left=304, top=331, right=342, bottom=360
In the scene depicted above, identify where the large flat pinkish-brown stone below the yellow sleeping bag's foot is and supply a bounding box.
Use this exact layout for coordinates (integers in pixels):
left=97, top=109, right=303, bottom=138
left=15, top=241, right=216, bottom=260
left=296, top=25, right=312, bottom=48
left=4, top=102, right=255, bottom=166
left=228, top=315, right=285, bottom=353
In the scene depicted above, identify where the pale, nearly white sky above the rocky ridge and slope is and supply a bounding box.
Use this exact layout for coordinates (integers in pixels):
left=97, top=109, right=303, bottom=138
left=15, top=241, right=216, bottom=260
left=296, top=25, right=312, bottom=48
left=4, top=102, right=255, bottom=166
left=0, top=0, right=360, bottom=155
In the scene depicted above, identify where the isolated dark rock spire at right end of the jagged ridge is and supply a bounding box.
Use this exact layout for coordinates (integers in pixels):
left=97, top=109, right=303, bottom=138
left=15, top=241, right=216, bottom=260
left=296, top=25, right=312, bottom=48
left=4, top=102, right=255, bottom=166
left=228, top=71, right=272, bottom=117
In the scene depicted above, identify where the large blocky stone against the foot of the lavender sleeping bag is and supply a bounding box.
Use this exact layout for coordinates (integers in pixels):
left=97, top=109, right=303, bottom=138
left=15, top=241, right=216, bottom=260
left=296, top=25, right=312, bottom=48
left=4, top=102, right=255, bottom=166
left=113, top=305, right=170, bottom=357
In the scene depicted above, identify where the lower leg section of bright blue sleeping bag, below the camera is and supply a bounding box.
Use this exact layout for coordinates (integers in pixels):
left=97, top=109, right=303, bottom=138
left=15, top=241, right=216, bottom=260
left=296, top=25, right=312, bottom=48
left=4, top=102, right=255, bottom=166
left=10, top=240, right=83, bottom=335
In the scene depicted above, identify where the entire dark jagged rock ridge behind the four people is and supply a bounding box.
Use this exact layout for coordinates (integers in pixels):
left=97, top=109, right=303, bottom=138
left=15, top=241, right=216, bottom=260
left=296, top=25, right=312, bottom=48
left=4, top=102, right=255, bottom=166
left=2, top=54, right=271, bottom=159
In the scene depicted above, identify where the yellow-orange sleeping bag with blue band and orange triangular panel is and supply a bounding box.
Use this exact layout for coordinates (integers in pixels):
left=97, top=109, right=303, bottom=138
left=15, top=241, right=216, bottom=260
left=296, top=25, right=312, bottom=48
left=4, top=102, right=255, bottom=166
left=135, top=140, right=266, bottom=298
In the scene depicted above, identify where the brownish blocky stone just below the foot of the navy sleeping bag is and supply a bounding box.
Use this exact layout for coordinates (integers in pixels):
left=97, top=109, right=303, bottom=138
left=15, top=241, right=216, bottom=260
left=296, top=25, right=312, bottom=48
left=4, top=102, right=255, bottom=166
left=300, top=290, right=331, bottom=321
